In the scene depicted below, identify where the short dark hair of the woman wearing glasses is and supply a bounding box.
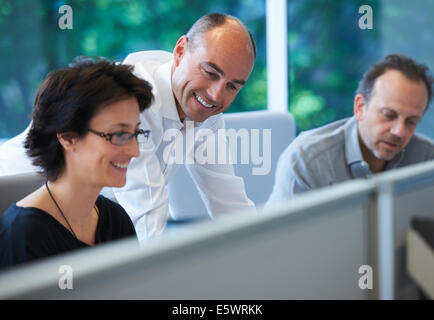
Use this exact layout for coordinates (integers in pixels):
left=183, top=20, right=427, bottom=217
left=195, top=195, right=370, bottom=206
left=24, top=57, right=153, bottom=181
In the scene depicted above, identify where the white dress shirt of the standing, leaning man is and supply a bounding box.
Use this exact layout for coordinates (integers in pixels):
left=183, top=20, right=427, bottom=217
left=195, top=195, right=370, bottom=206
left=0, top=51, right=254, bottom=241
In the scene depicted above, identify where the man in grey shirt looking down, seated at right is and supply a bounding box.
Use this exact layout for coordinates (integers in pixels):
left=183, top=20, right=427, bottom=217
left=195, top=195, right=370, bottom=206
left=267, top=54, right=434, bottom=205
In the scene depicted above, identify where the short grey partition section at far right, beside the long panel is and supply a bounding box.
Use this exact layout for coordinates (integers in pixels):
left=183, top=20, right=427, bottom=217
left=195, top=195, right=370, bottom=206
left=374, top=161, right=434, bottom=299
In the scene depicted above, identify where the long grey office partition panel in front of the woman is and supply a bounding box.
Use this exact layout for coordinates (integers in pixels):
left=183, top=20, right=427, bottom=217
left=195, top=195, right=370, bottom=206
left=0, top=181, right=375, bottom=299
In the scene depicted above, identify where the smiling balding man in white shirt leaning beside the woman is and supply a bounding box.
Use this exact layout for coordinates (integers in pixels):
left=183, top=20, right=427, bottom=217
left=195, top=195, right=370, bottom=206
left=0, top=14, right=256, bottom=241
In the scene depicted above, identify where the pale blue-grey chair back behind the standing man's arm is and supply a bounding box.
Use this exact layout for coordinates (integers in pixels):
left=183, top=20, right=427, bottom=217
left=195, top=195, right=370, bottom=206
left=167, top=111, right=296, bottom=221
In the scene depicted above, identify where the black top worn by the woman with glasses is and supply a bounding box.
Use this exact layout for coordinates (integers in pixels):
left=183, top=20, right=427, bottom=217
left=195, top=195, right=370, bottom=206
left=0, top=195, right=137, bottom=269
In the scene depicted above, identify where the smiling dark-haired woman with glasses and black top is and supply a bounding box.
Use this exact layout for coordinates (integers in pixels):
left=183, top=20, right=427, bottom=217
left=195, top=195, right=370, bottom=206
left=0, top=59, right=153, bottom=268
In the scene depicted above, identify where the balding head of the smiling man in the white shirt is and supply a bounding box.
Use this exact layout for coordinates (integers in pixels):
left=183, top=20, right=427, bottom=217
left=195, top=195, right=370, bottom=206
left=172, top=14, right=255, bottom=122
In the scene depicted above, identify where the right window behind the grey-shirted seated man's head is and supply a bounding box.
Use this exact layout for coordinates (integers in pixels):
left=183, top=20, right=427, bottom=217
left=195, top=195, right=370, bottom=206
left=287, top=0, right=434, bottom=138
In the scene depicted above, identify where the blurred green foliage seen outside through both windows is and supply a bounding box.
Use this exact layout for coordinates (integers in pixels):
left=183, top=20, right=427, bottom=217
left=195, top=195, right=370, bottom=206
left=4, top=0, right=432, bottom=139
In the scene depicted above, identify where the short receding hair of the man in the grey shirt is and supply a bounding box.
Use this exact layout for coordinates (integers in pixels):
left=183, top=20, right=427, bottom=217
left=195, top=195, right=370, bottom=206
left=356, top=54, right=433, bottom=107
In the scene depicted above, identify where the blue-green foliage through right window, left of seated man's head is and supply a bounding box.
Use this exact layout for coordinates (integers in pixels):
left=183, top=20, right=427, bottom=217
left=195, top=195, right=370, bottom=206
left=288, top=0, right=380, bottom=131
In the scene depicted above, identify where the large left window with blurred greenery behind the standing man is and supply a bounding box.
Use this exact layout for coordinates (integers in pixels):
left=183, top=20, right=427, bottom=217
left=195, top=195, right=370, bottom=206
left=0, top=0, right=266, bottom=139
